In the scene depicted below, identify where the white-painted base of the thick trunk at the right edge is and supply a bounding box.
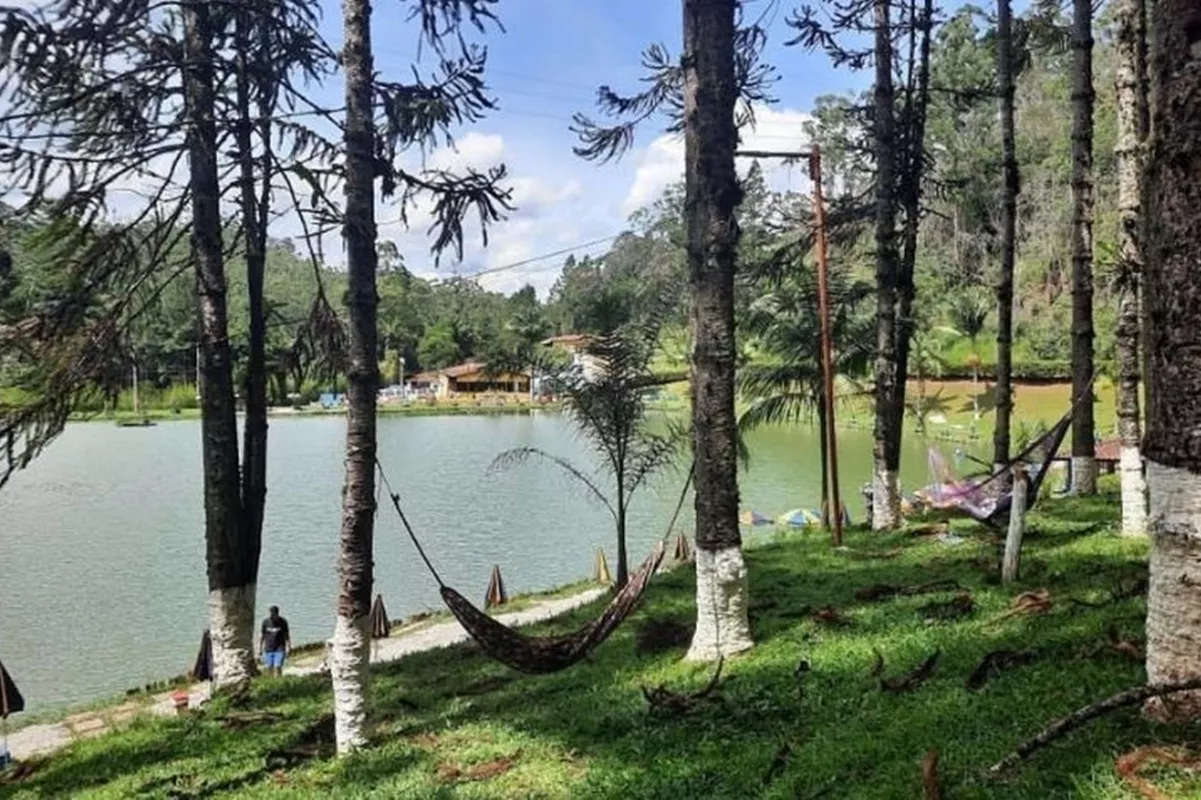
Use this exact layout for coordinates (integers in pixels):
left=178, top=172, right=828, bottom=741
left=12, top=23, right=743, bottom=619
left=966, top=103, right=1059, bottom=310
left=1145, top=461, right=1201, bottom=722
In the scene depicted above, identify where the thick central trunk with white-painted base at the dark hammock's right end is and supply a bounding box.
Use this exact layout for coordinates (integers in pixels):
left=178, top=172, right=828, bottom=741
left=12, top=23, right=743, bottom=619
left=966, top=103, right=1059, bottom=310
left=683, top=0, right=752, bottom=661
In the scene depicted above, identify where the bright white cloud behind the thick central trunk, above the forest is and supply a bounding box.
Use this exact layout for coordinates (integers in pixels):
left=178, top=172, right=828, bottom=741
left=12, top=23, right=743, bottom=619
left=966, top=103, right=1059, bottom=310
left=621, top=106, right=812, bottom=216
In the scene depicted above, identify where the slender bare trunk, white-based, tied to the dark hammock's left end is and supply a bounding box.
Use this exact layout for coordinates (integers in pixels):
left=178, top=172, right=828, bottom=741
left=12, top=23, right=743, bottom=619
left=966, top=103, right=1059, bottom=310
left=329, top=0, right=380, bottom=754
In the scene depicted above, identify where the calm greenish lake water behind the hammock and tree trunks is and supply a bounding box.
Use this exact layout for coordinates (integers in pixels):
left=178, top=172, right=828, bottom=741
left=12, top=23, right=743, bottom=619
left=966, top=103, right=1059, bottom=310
left=0, top=414, right=946, bottom=711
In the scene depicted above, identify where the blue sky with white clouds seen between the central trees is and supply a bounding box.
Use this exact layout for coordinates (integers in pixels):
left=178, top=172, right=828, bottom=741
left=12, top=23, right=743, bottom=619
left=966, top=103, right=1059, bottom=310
left=290, top=0, right=883, bottom=292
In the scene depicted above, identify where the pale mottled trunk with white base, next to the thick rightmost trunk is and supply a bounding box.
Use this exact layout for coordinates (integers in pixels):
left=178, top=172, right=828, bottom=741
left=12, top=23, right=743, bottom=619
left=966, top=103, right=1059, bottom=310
left=1115, top=0, right=1147, bottom=536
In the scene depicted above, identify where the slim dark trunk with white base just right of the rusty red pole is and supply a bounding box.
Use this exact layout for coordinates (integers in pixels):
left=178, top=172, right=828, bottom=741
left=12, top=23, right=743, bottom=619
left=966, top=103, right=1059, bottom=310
left=872, top=0, right=904, bottom=531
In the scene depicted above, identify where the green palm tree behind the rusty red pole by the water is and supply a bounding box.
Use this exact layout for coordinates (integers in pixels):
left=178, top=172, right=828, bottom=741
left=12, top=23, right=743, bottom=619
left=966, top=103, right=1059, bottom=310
left=739, top=269, right=873, bottom=524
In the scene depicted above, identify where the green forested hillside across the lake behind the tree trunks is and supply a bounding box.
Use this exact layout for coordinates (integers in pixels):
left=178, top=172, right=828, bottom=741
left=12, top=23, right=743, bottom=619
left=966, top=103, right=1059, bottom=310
left=2, top=6, right=1118, bottom=407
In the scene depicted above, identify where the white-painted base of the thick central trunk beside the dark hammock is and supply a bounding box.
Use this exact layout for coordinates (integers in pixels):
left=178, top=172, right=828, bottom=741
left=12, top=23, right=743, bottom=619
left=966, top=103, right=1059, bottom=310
left=685, top=547, right=754, bottom=661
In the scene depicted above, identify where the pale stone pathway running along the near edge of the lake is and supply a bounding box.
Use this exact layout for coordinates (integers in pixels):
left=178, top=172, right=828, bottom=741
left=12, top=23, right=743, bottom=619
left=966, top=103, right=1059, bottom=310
left=8, top=589, right=607, bottom=760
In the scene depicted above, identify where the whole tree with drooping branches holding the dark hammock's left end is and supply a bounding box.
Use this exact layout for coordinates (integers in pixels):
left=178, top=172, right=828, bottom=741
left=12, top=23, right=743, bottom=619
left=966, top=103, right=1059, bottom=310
left=329, top=0, right=508, bottom=753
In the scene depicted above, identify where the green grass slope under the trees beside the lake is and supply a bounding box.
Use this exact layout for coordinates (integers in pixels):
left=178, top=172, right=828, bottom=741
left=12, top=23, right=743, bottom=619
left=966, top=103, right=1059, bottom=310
left=7, top=475, right=1201, bottom=800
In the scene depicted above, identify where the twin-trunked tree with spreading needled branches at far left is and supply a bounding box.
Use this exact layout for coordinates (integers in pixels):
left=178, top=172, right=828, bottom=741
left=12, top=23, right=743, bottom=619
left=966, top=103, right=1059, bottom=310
left=0, top=0, right=333, bottom=686
